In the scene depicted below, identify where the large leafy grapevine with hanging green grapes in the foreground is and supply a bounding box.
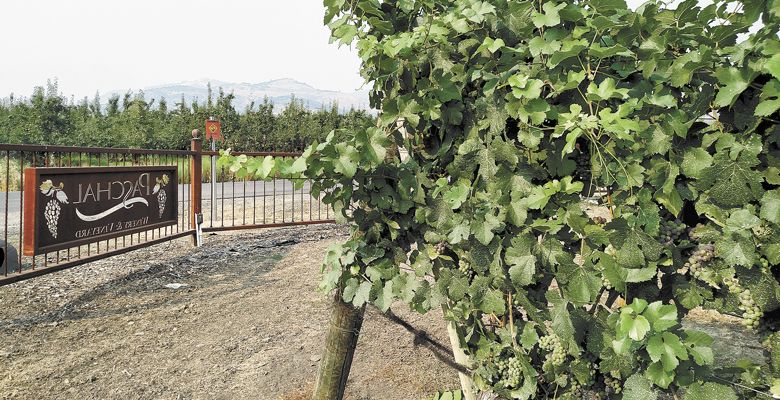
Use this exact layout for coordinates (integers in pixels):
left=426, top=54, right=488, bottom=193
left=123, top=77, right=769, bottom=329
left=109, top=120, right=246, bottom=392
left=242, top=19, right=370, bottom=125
left=224, top=0, right=780, bottom=399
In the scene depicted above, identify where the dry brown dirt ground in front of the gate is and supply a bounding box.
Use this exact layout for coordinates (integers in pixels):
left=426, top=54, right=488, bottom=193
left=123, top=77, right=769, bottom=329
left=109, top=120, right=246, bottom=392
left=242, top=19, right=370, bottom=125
left=0, top=225, right=458, bottom=400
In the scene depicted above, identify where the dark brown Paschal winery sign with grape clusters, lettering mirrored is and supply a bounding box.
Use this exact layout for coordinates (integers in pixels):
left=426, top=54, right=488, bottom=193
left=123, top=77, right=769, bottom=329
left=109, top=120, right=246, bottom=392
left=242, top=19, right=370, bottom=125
left=24, top=166, right=178, bottom=256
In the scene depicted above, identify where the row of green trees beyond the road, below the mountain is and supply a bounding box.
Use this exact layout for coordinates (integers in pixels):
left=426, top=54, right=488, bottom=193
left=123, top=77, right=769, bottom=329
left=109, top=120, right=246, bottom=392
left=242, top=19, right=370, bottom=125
left=0, top=81, right=374, bottom=151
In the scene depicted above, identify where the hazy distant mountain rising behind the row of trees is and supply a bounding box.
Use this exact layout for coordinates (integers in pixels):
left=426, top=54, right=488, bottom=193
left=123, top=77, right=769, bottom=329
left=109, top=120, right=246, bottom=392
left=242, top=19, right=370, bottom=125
left=109, top=79, right=370, bottom=112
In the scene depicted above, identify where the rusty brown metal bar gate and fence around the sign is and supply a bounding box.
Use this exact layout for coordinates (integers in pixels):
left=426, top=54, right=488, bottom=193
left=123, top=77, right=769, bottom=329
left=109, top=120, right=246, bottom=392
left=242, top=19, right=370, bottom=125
left=0, top=138, right=334, bottom=286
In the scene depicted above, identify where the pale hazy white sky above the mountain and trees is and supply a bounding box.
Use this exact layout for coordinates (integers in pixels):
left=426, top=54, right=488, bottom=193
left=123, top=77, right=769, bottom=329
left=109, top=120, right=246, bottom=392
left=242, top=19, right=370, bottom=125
left=0, top=0, right=724, bottom=98
